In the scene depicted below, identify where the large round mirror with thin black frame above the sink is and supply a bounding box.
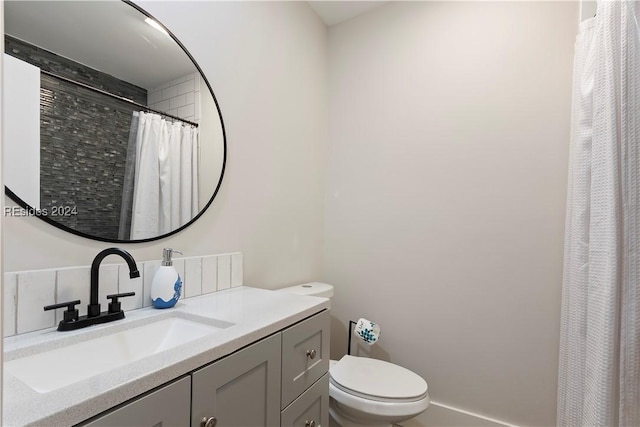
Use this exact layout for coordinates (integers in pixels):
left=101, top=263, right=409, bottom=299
left=2, top=0, right=226, bottom=242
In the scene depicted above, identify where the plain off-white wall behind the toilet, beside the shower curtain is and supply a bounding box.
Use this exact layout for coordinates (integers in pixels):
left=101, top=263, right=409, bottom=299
left=323, top=2, right=579, bottom=426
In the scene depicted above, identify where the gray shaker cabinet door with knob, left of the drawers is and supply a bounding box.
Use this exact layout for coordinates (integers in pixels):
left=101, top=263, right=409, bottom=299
left=191, top=334, right=281, bottom=427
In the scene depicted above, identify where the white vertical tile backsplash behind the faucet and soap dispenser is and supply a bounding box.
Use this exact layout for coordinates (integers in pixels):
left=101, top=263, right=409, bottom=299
left=2, top=252, right=243, bottom=337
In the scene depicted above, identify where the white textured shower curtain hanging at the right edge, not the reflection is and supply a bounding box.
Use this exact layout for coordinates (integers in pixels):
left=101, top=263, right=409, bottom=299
left=557, top=1, right=640, bottom=427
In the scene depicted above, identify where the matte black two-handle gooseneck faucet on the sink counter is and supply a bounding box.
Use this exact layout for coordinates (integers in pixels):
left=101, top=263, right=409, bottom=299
left=44, top=248, right=140, bottom=331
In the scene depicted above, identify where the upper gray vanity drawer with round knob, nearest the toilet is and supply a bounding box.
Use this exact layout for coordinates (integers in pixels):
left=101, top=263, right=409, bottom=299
left=281, top=311, right=330, bottom=409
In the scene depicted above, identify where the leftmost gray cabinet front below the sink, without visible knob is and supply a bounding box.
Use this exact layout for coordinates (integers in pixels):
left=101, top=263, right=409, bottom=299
left=84, top=377, right=191, bottom=427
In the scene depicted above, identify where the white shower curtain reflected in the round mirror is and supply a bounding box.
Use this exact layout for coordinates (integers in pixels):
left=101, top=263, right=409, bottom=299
left=120, top=111, right=199, bottom=240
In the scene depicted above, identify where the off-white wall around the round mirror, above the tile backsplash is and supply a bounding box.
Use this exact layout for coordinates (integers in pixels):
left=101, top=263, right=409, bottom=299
left=3, top=1, right=327, bottom=294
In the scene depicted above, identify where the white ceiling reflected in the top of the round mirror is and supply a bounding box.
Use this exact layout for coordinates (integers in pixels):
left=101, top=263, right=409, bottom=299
left=4, top=1, right=196, bottom=89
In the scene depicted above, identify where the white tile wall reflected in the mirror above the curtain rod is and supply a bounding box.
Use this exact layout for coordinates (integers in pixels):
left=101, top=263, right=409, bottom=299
left=147, top=73, right=201, bottom=123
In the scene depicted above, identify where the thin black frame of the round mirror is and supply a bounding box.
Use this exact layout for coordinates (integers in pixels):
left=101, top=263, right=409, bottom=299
left=4, top=0, right=227, bottom=243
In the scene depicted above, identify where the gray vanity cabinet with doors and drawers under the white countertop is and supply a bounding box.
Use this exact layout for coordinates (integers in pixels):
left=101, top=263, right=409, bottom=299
left=76, top=310, right=330, bottom=427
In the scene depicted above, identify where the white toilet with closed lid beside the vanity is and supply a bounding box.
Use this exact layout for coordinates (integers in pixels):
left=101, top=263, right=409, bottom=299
left=280, top=282, right=429, bottom=427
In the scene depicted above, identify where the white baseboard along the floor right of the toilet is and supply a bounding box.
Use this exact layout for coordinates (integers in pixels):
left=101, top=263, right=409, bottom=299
left=400, top=401, right=517, bottom=427
